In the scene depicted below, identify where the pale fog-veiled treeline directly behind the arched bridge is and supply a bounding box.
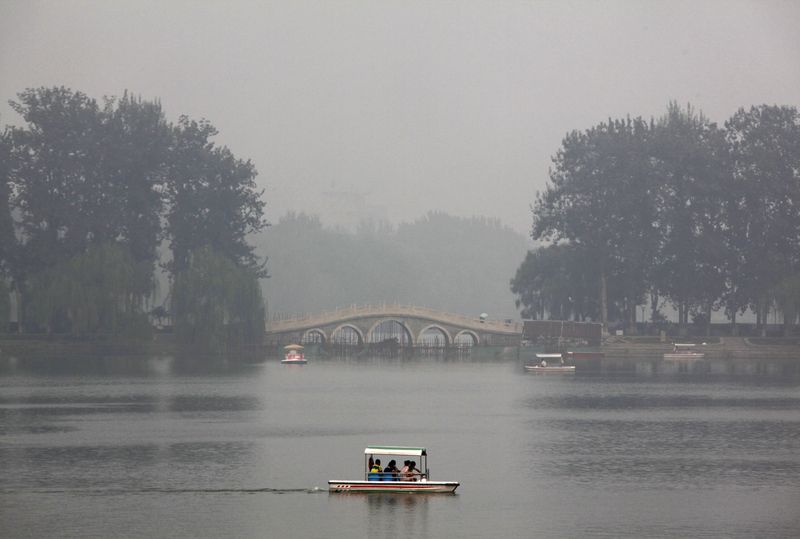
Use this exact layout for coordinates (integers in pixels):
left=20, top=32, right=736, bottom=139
left=255, top=212, right=529, bottom=319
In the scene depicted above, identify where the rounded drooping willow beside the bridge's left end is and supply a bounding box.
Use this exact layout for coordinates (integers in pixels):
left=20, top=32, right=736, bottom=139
left=172, top=247, right=265, bottom=351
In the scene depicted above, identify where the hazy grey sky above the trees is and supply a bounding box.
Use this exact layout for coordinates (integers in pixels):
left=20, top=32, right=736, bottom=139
left=0, top=0, right=800, bottom=233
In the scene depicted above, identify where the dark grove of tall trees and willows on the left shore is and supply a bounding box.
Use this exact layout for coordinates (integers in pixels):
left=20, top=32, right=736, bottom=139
left=0, top=87, right=266, bottom=345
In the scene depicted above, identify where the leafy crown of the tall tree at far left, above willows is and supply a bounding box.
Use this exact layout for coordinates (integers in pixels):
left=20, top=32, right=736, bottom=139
left=11, top=88, right=104, bottom=274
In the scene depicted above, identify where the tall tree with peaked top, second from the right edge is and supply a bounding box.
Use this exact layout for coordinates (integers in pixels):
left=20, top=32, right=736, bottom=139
left=653, top=103, right=731, bottom=332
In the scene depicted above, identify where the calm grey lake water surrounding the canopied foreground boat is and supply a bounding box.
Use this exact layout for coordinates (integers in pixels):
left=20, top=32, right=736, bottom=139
left=0, top=358, right=800, bottom=538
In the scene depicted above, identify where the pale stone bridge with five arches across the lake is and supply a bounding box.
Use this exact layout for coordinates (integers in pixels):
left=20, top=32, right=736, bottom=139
left=266, top=304, right=522, bottom=347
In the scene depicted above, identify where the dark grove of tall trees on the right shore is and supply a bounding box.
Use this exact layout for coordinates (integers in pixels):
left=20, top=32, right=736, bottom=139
left=511, top=103, right=800, bottom=333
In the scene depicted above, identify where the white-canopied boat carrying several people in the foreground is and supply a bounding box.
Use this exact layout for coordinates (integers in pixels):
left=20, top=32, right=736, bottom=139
left=328, top=445, right=459, bottom=493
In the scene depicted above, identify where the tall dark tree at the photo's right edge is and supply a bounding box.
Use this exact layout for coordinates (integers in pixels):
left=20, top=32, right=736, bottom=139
left=725, top=105, right=800, bottom=332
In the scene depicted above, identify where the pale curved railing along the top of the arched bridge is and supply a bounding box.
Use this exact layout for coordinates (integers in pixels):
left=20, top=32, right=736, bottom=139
left=267, top=303, right=522, bottom=333
